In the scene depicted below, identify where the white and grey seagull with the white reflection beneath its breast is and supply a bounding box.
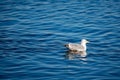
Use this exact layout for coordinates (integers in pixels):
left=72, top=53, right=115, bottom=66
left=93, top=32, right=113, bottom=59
left=65, top=39, right=89, bottom=57
